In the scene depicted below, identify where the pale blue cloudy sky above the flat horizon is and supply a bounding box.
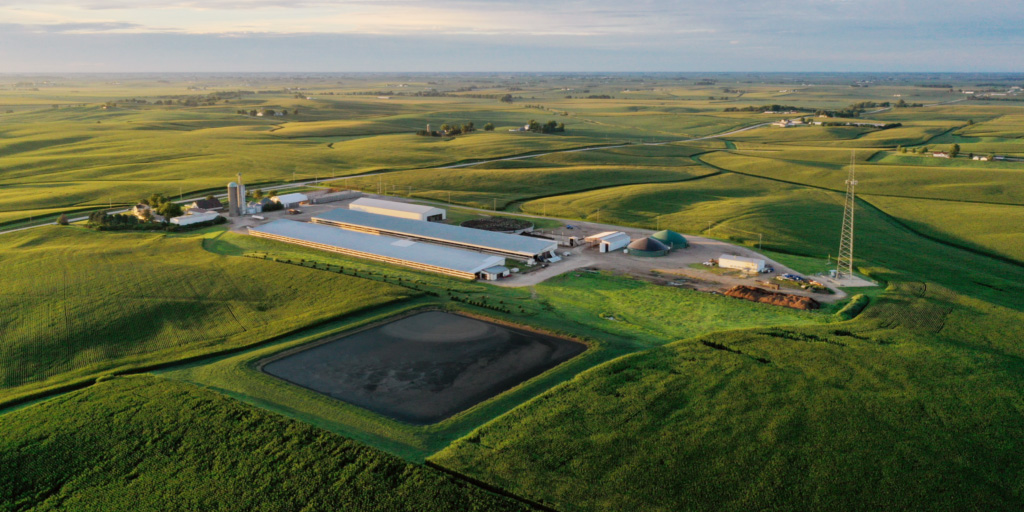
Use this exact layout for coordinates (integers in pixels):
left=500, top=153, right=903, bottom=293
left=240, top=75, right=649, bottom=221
left=0, top=0, right=1024, bottom=73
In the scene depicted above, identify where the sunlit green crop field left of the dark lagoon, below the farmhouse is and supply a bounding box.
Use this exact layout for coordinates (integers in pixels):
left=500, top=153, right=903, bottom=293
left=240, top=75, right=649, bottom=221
left=0, top=227, right=416, bottom=402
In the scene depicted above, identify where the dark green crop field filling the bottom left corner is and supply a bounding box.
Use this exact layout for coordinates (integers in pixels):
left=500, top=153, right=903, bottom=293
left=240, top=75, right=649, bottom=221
left=0, top=376, right=526, bottom=512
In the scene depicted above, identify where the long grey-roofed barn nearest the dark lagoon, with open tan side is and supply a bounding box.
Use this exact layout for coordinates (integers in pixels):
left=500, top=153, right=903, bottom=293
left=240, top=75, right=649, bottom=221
left=249, top=219, right=505, bottom=280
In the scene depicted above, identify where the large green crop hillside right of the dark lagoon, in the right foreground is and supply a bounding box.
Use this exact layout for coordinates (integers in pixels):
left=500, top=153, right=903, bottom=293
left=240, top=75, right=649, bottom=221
left=432, top=284, right=1024, bottom=512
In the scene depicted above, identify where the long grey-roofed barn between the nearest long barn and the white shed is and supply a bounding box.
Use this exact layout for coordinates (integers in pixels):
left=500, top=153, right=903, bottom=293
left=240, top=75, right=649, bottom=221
left=312, top=208, right=558, bottom=261
